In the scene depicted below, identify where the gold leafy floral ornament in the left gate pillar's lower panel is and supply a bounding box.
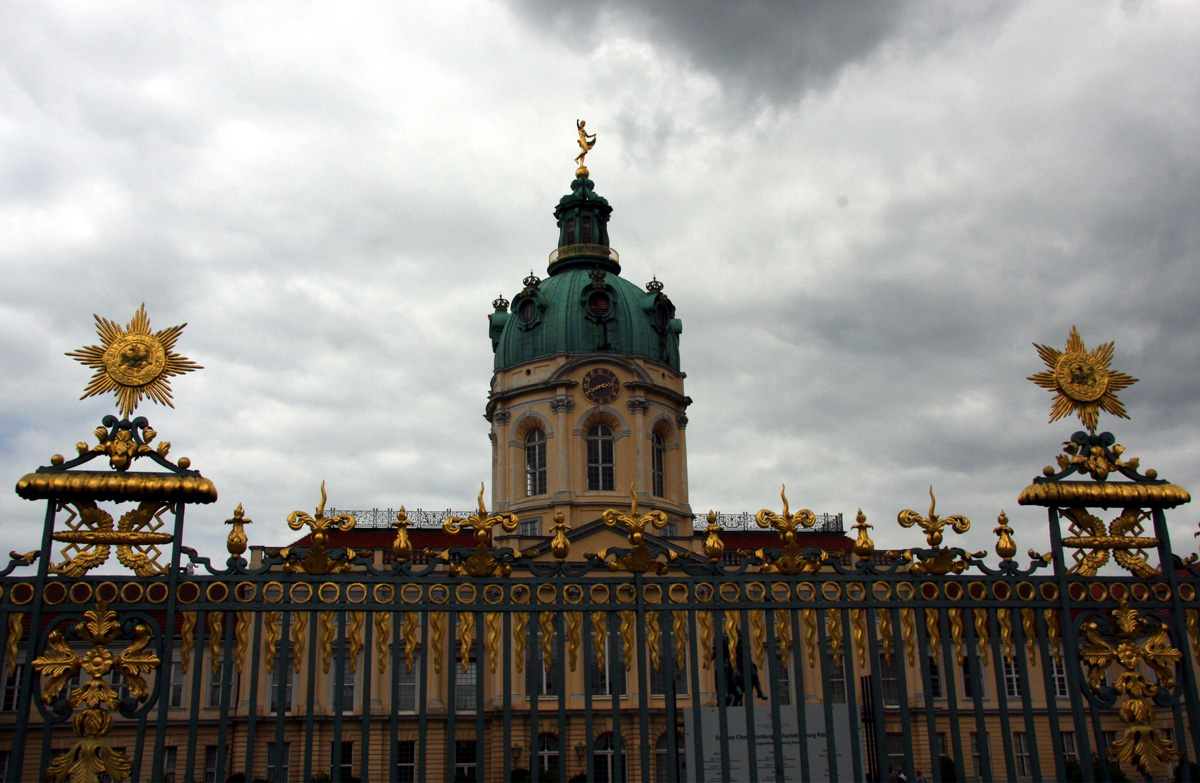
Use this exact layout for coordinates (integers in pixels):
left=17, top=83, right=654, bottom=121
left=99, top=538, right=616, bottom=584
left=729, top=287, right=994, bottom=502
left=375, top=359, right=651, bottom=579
left=32, top=602, right=162, bottom=783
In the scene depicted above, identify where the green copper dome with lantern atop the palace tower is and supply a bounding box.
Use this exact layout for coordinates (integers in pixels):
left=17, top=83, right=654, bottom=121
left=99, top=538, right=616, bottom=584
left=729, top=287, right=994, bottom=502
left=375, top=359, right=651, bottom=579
left=488, top=178, right=683, bottom=371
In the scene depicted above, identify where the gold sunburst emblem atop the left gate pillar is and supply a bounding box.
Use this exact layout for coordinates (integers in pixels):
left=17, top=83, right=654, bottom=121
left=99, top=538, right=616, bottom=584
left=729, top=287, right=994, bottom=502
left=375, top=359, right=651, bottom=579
left=67, top=304, right=204, bottom=418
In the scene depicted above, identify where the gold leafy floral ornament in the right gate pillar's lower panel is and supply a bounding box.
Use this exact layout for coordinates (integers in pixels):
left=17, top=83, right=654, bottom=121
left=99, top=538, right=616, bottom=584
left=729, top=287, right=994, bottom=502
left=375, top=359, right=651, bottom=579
left=1080, top=600, right=1183, bottom=778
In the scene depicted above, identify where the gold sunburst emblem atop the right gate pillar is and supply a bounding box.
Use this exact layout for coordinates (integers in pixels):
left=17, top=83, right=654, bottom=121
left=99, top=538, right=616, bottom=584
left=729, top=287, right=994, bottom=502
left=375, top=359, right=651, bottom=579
left=1030, top=327, right=1138, bottom=431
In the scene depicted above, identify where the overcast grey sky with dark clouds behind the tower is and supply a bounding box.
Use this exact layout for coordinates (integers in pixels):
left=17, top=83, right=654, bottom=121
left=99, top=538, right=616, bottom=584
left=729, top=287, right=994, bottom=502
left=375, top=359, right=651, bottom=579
left=0, top=0, right=1200, bottom=560
